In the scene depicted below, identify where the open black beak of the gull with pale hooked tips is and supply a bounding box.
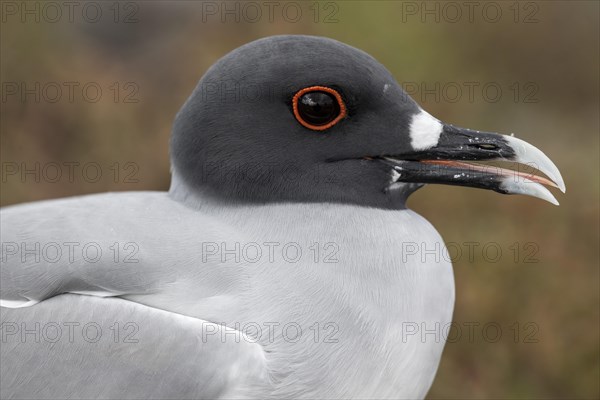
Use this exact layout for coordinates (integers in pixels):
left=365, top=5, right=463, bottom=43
left=379, top=125, right=565, bottom=205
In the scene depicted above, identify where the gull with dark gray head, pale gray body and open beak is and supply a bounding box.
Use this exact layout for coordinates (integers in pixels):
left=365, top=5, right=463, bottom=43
left=0, top=35, right=565, bottom=399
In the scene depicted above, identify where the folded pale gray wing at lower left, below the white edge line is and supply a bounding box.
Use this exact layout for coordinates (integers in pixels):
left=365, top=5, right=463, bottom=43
left=0, top=294, right=267, bottom=399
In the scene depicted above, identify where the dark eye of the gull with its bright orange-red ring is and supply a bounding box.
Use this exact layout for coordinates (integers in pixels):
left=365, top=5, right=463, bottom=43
left=293, top=86, right=346, bottom=131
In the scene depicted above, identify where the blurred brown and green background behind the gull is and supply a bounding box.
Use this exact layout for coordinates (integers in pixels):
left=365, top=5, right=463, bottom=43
left=0, top=1, right=600, bottom=399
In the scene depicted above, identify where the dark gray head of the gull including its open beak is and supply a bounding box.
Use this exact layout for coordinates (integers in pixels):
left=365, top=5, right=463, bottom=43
left=171, top=36, right=564, bottom=208
